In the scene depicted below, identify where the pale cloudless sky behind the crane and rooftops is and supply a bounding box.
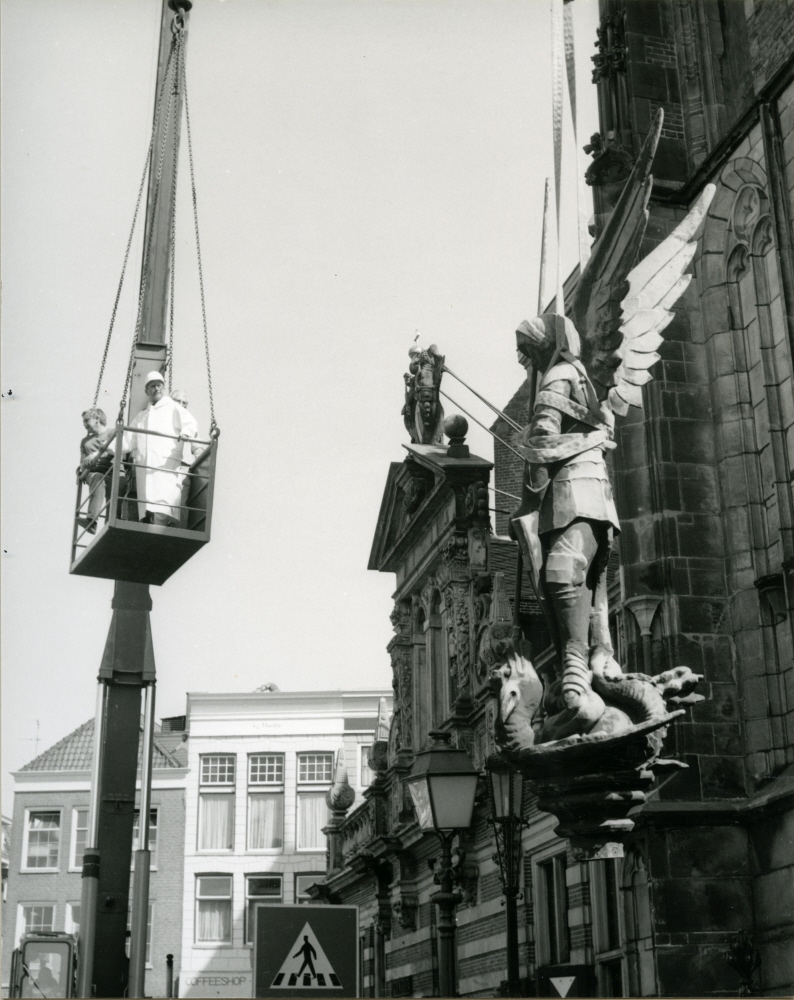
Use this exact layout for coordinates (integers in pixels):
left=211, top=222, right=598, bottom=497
left=0, top=0, right=598, bottom=814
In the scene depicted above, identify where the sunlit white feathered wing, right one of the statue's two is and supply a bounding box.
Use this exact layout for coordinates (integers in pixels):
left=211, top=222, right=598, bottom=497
left=608, top=184, right=716, bottom=416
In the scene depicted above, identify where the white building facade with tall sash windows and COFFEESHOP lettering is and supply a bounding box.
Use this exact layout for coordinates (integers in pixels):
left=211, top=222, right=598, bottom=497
left=178, top=685, right=391, bottom=997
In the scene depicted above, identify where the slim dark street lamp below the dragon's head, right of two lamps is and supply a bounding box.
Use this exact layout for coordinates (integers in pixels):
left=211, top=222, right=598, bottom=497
left=485, top=756, right=524, bottom=997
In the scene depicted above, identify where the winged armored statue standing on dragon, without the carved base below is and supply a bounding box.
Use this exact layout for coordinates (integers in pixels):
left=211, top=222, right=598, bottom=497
left=496, top=112, right=714, bottom=750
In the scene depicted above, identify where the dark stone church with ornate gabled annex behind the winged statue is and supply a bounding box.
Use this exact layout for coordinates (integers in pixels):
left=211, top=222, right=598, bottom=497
left=321, top=0, right=794, bottom=996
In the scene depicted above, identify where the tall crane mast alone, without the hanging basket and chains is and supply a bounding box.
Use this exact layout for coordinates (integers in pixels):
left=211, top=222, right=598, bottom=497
left=78, top=0, right=192, bottom=997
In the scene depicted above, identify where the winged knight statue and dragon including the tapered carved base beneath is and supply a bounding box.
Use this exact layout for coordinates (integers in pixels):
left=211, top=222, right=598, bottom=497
left=486, top=112, right=715, bottom=851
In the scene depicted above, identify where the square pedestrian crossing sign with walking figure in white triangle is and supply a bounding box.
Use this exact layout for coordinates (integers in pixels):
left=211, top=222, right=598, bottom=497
left=254, top=905, right=359, bottom=1000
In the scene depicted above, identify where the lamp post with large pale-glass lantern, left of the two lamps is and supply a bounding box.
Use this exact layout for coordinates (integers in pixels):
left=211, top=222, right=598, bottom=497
left=406, top=732, right=479, bottom=997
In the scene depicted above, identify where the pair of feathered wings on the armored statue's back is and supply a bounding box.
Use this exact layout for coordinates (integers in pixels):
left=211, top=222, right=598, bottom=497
left=572, top=109, right=714, bottom=416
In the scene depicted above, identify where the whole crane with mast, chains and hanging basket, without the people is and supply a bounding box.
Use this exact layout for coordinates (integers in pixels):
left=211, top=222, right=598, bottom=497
left=70, top=0, right=219, bottom=997
